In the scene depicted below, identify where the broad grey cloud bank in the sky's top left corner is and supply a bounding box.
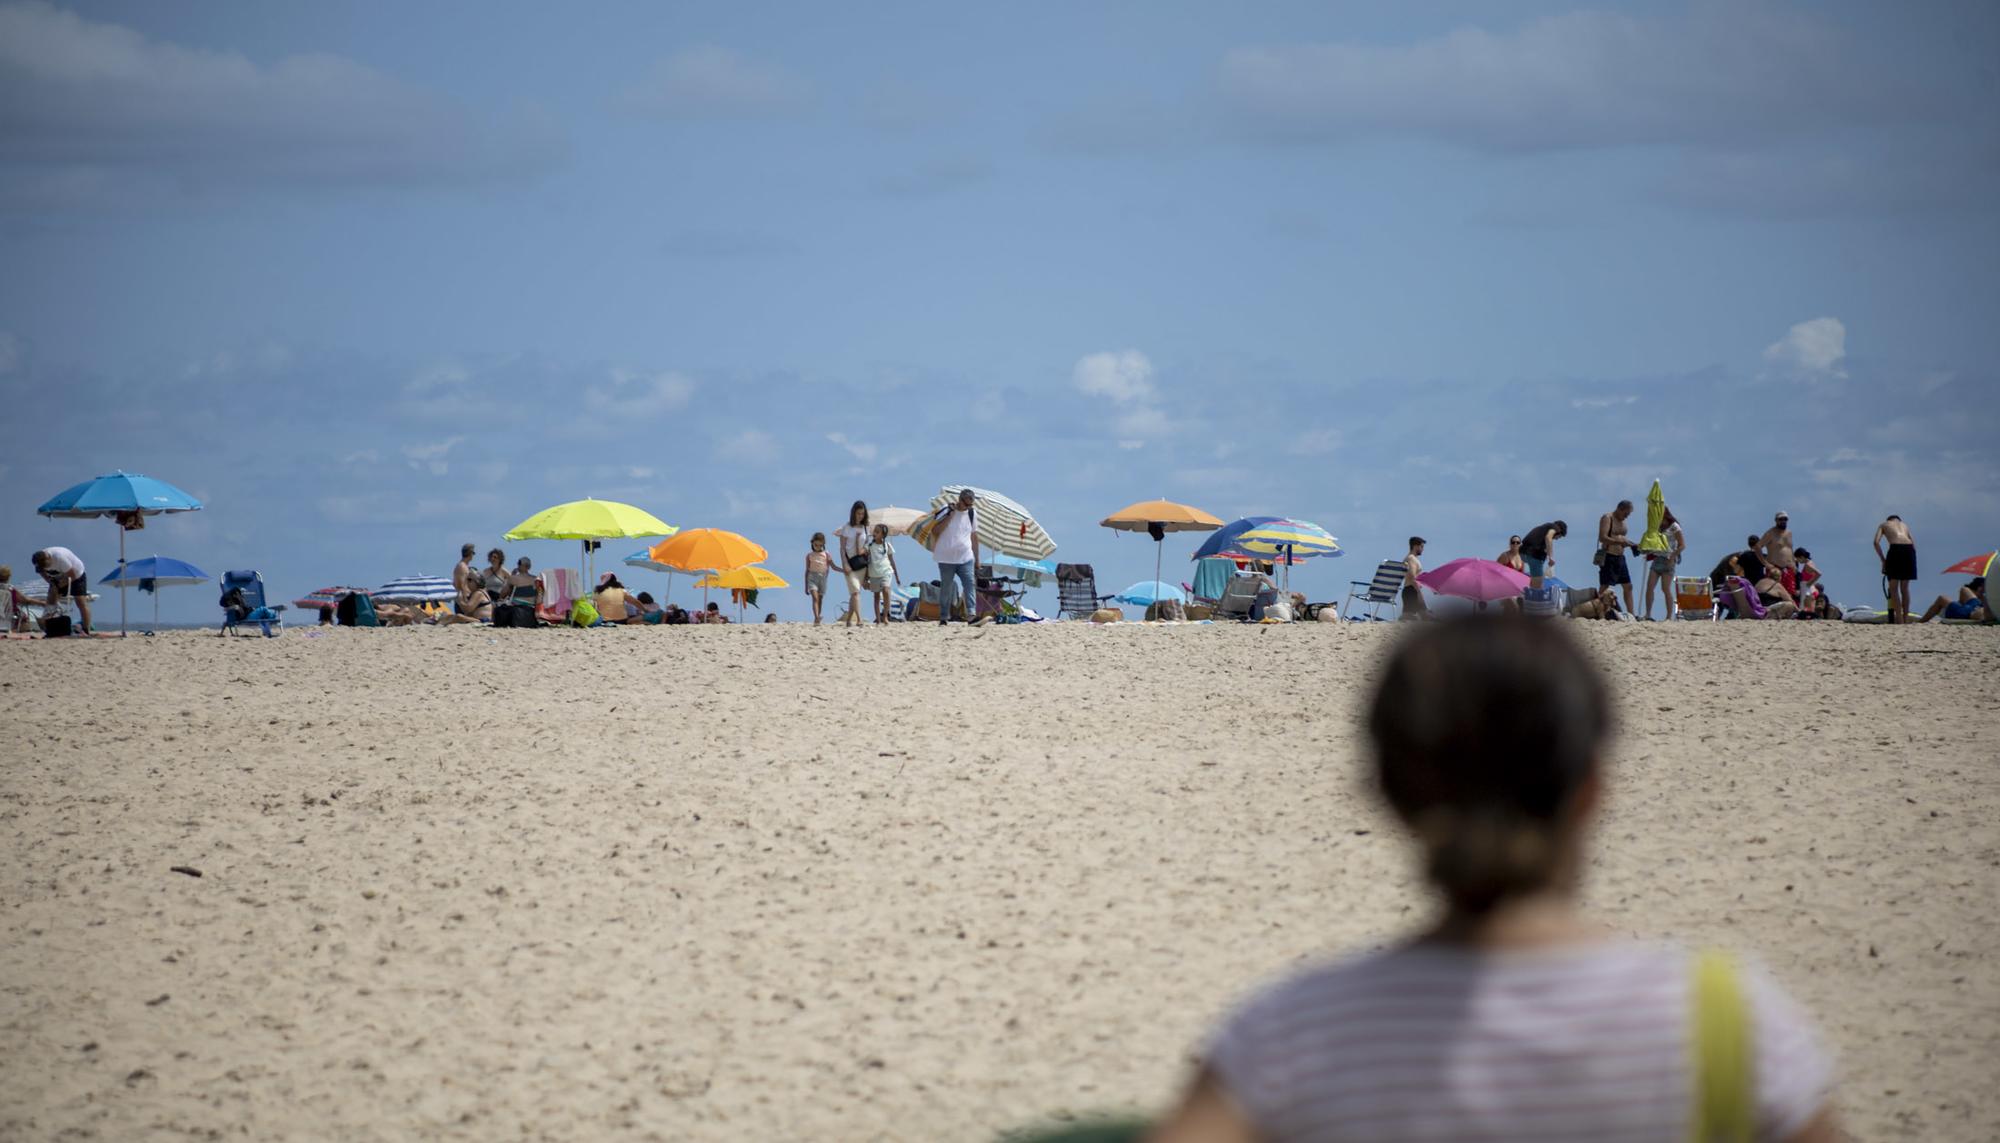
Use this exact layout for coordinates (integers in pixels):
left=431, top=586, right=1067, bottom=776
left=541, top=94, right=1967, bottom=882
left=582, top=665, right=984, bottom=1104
left=0, top=0, right=566, bottom=196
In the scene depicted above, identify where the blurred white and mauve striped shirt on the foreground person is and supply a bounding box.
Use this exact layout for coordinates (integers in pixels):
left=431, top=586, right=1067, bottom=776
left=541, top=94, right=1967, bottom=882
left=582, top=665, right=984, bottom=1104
left=1206, top=941, right=1832, bottom=1143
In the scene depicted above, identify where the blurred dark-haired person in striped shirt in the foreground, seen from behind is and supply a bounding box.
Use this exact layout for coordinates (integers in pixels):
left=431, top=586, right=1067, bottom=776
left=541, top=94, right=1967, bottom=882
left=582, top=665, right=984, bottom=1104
left=1152, top=617, right=1840, bottom=1143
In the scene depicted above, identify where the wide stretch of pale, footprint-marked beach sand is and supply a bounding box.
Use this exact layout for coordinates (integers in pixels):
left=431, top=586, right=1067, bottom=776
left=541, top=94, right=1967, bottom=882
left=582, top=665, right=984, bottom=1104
left=0, top=623, right=2000, bottom=1141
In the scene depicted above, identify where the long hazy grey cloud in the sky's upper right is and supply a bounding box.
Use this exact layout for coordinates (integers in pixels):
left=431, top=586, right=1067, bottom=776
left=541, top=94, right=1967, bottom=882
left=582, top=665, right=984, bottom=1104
left=1218, top=4, right=1952, bottom=150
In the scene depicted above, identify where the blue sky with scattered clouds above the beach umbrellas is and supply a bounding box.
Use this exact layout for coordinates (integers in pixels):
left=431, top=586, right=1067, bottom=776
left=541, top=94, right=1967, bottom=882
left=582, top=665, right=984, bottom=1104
left=0, top=2, right=2000, bottom=619
